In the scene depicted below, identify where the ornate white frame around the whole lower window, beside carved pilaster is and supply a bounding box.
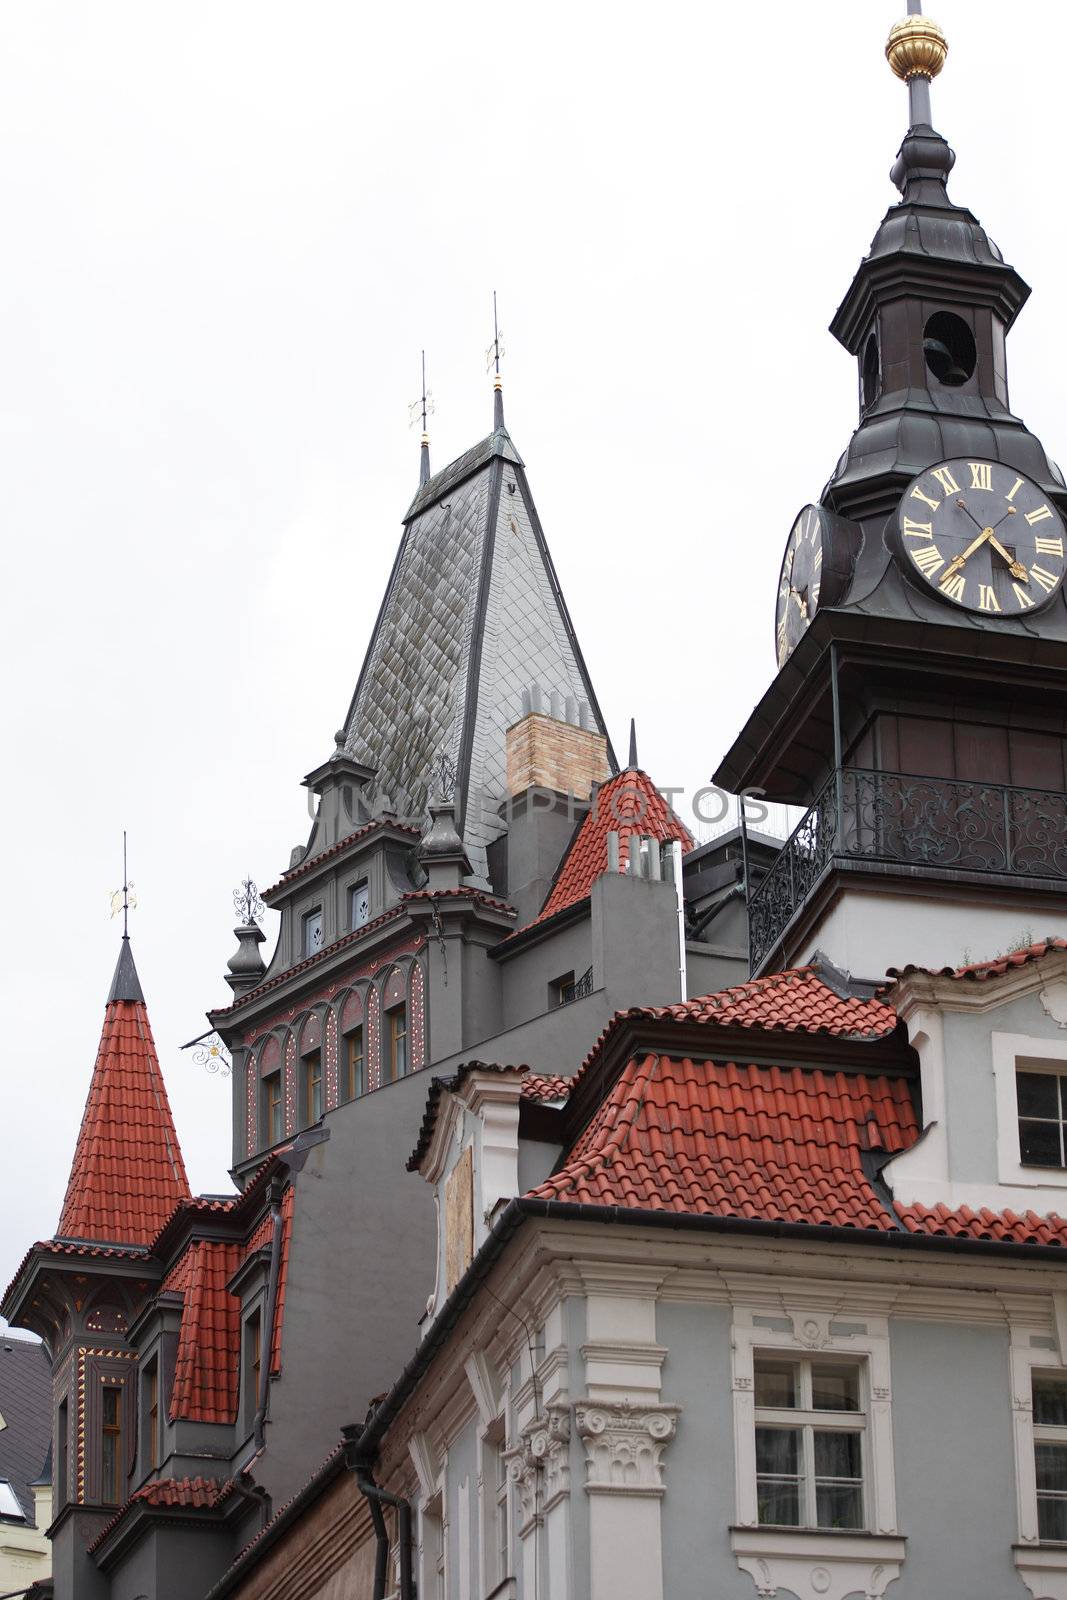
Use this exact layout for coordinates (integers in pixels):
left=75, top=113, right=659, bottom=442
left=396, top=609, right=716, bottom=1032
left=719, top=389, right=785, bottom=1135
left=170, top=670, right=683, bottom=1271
left=729, top=1299, right=908, bottom=1600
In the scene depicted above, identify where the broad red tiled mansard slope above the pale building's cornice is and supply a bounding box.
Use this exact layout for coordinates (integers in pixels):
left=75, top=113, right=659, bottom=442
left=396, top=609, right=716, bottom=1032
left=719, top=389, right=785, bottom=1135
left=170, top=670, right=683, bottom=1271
left=531, top=1054, right=918, bottom=1232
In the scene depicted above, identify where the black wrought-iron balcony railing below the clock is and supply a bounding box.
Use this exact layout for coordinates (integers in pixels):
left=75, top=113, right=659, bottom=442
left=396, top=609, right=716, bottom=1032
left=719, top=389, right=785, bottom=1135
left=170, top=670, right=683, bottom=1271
left=749, top=766, right=1067, bottom=971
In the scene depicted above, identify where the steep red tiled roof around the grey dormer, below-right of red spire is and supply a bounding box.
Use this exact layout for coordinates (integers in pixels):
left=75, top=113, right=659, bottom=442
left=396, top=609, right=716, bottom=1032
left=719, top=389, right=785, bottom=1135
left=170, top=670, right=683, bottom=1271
left=162, top=1189, right=293, bottom=1422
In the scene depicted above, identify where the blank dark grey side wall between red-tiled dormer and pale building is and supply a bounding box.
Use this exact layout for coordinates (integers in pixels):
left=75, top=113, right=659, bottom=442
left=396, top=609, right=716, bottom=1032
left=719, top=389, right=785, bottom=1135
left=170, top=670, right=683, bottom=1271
left=256, top=1072, right=437, bottom=1506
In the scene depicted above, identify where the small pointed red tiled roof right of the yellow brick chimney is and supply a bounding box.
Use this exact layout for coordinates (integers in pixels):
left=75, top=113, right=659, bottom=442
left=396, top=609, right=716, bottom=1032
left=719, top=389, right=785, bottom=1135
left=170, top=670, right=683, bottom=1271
left=530, top=766, right=693, bottom=926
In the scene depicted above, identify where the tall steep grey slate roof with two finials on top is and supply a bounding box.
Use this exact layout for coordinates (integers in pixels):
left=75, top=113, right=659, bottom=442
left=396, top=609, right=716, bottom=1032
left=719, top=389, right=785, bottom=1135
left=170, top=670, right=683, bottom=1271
left=337, top=421, right=614, bottom=880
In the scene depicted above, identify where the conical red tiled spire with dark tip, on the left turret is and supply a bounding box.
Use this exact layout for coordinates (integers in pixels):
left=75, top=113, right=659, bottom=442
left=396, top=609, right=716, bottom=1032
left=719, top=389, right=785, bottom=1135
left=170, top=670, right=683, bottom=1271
left=56, top=934, right=190, bottom=1245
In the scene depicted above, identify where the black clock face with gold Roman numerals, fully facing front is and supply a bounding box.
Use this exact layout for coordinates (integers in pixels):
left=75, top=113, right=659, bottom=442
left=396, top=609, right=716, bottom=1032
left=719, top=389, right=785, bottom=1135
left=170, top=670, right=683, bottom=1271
left=897, top=456, right=1064, bottom=616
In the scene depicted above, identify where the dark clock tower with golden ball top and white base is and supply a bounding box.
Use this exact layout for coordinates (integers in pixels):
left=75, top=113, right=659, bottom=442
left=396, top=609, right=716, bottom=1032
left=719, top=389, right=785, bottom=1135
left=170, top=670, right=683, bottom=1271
left=715, top=0, right=1067, bottom=979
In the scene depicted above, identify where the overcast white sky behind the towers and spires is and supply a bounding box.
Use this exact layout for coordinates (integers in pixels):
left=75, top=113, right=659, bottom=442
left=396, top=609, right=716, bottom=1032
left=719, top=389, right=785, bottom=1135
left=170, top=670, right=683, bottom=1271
left=0, top=0, right=1067, bottom=1283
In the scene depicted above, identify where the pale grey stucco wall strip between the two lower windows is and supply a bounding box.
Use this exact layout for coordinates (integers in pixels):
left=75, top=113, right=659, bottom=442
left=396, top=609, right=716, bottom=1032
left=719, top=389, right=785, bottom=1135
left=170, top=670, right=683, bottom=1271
left=891, top=1322, right=1030, bottom=1600
